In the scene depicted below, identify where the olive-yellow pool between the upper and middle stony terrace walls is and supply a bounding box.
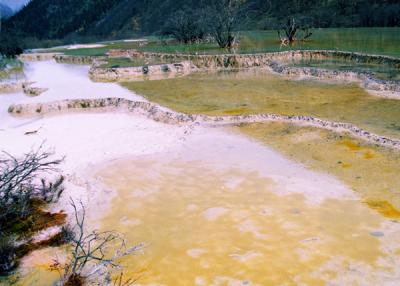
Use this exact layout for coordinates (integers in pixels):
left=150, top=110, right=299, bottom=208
left=123, top=70, right=400, bottom=138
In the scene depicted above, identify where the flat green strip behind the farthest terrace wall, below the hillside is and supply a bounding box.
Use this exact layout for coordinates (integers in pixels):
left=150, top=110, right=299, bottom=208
left=140, top=28, right=400, bottom=57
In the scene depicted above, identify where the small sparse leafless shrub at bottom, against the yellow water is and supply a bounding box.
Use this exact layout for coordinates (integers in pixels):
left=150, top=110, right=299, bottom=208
left=63, top=200, right=143, bottom=285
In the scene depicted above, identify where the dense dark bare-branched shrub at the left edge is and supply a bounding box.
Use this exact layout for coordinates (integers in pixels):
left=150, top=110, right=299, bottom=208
left=0, top=147, right=64, bottom=274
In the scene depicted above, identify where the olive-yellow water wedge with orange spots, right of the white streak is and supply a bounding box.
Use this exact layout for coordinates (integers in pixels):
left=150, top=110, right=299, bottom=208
left=235, top=122, right=400, bottom=213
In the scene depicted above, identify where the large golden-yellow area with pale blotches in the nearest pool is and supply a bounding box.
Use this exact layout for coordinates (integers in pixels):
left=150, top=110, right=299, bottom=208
left=98, top=146, right=400, bottom=285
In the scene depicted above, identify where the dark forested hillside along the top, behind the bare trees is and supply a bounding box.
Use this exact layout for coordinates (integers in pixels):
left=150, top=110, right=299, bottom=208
left=3, top=0, right=400, bottom=46
